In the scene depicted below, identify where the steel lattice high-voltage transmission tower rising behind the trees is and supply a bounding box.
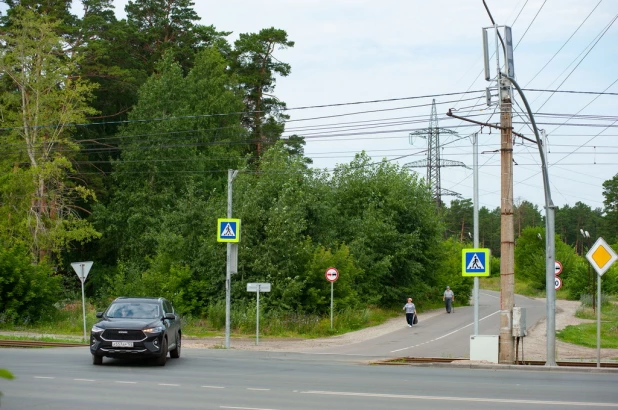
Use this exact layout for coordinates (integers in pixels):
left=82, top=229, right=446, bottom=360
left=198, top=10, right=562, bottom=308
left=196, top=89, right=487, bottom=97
left=404, top=100, right=469, bottom=206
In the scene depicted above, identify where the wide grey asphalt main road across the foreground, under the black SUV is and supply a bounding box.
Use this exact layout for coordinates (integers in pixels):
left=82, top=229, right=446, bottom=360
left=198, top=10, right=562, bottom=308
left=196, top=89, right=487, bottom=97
left=0, top=347, right=618, bottom=410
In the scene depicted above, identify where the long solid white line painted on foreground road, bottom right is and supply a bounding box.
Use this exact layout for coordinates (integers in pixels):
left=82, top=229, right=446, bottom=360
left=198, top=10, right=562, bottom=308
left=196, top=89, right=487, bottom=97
left=300, top=391, right=618, bottom=408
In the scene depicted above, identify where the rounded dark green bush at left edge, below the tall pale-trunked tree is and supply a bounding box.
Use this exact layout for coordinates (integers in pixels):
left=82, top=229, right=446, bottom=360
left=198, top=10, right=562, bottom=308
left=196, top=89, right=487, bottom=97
left=0, top=246, right=61, bottom=323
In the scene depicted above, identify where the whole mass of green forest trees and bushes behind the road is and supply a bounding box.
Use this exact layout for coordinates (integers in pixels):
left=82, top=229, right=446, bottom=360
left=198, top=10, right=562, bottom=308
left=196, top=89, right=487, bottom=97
left=0, top=0, right=618, bottom=324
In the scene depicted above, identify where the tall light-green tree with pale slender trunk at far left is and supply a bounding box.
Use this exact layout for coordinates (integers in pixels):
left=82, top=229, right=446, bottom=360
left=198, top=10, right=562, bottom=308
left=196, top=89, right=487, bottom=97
left=0, top=6, right=98, bottom=259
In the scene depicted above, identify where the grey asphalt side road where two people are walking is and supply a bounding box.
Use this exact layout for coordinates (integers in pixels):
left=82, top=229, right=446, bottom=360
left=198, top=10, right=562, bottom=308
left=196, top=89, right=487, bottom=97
left=306, top=290, right=545, bottom=358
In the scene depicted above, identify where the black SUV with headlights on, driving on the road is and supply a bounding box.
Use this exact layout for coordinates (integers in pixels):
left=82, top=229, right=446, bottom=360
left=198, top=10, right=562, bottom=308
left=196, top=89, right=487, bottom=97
left=90, top=298, right=182, bottom=366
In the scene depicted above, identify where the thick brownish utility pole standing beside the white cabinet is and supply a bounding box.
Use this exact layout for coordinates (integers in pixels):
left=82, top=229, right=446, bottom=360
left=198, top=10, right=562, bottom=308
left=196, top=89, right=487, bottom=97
left=498, top=78, right=515, bottom=363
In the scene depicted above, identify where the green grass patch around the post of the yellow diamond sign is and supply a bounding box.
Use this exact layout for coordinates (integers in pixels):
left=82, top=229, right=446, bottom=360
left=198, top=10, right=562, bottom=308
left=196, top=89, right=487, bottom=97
left=556, top=303, right=618, bottom=349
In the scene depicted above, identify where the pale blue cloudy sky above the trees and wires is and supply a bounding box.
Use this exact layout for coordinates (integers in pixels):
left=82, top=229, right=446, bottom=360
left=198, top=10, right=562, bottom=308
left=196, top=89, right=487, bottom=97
left=102, top=0, right=618, bottom=212
